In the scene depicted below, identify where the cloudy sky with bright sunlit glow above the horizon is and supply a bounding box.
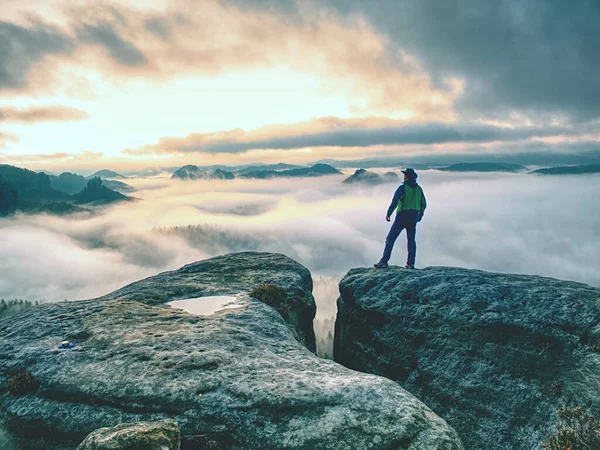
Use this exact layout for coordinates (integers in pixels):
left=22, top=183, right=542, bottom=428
left=0, top=0, right=600, bottom=170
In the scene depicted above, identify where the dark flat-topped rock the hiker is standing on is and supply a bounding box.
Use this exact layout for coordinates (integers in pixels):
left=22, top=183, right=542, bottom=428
left=334, top=267, right=600, bottom=450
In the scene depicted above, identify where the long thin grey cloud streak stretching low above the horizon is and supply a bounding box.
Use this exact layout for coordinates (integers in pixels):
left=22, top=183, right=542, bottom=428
left=123, top=118, right=572, bottom=155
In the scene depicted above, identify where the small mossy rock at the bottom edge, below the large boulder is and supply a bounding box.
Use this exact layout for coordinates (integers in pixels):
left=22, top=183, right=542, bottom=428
left=77, top=419, right=179, bottom=450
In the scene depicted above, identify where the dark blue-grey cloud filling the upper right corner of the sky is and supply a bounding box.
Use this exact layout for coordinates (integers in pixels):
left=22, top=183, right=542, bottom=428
left=247, top=0, right=600, bottom=120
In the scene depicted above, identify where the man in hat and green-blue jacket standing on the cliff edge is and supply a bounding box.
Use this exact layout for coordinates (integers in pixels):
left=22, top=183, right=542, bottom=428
left=375, top=169, right=427, bottom=269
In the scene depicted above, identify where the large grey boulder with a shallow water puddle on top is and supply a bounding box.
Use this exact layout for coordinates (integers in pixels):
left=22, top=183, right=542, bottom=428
left=0, top=253, right=463, bottom=450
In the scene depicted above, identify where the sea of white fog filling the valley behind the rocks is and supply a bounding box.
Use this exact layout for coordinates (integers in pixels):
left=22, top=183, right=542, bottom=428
left=0, top=171, right=600, bottom=308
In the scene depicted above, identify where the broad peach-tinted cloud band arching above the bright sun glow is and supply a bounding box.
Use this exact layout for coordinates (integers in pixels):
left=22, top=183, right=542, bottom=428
left=0, top=0, right=461, bottom=120
